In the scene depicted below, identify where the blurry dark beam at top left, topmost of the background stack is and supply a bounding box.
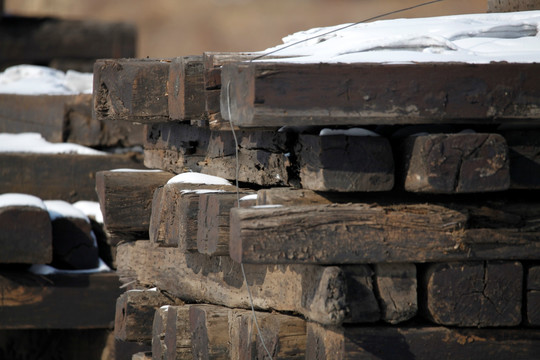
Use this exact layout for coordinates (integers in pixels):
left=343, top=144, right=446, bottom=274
left=0, top=16, right=136, bottom=72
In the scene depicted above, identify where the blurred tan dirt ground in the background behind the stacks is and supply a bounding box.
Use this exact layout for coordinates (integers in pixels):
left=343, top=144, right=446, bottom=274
left=4, top=0, right=487, bottom=58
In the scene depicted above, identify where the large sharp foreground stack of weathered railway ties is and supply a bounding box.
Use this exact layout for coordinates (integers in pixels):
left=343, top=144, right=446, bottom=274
left=93, top=53, right=540, bottom=359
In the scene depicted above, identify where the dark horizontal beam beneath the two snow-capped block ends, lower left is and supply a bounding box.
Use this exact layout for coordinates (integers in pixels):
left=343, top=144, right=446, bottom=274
left=0, top=272, right=120, bottom=329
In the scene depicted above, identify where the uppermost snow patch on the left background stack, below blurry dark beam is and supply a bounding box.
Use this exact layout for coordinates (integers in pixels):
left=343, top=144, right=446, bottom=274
left=0, top=65, right=93, bottom=95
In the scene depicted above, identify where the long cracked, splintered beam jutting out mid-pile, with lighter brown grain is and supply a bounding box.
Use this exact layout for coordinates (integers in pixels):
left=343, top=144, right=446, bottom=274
left=229, top=204, right=540, bottom=264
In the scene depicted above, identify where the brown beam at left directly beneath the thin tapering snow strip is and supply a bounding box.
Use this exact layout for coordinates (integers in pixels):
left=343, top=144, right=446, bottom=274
left=0, top=153, right=143, bottom=203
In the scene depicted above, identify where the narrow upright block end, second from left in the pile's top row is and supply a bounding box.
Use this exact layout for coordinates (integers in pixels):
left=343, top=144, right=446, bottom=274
left=167, top=56, right=206, bottom=121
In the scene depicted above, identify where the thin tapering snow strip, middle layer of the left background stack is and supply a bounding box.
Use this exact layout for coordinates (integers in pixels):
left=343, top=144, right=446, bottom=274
left=0, top=133, right=106, bottom=155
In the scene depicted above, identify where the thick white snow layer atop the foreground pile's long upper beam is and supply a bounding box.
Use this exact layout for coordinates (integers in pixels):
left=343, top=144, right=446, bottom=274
left=258, top=11, right=540, bottom=63
